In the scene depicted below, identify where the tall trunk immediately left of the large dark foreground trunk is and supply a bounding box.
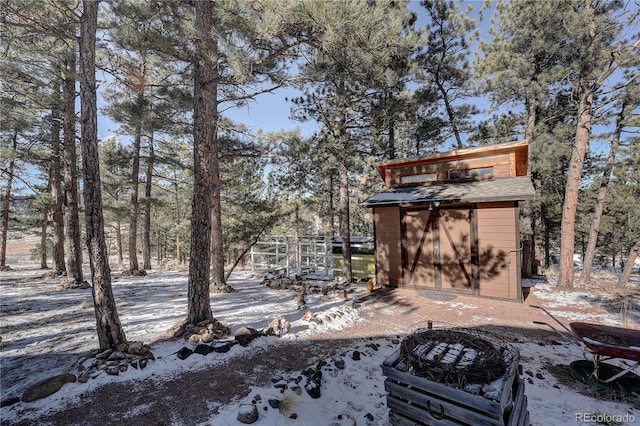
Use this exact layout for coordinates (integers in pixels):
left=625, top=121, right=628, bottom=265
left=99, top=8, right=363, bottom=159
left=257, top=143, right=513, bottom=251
left=62, top=50, right=84, bottom=282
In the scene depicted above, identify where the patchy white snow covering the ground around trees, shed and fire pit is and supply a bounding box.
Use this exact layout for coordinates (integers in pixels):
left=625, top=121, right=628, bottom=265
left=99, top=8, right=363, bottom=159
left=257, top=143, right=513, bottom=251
left=0, top=267, right=640, bottom=426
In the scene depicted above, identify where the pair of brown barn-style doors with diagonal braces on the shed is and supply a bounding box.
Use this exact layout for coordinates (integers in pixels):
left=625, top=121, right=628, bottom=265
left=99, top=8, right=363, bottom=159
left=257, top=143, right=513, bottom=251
left=402, top=207, right=477, bottom=293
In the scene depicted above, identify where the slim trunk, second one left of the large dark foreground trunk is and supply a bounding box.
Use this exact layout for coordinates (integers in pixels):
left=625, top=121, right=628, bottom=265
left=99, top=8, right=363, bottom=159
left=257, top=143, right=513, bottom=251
left=49, top=84, right=67, bottom=275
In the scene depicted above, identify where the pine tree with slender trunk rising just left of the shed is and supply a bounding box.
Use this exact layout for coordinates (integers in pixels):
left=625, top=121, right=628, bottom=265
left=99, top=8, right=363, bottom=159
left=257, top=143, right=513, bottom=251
left=293, top=1, right=412, bottom=281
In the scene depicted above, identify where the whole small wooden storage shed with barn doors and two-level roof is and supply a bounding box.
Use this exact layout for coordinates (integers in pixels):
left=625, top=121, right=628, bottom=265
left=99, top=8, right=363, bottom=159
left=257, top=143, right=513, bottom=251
left=365, top=141, right=534, bottom=302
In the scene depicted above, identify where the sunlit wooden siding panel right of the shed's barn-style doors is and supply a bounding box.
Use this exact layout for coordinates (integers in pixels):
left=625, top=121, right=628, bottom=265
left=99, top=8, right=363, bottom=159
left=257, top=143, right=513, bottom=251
left=478, top=202, right=520, bottom=299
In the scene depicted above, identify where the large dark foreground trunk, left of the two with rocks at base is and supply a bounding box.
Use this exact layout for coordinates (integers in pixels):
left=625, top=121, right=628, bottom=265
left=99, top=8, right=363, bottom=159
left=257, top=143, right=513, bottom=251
left=80, top=0, right=128, bottom=351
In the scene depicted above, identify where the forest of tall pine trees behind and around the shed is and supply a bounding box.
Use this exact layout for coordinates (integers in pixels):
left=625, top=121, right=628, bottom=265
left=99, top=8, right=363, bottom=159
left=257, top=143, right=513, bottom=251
left=0, top=0, right=640, bottom=348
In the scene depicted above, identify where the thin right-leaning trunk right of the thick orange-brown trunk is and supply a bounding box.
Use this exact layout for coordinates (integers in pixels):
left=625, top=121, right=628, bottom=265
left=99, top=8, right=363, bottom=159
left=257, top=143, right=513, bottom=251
left=582, top=96, right=629, bottom=280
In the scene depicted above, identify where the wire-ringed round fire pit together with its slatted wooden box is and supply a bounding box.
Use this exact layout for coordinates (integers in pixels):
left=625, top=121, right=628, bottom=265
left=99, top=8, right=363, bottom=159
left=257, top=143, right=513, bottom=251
left=382, top=329, right=529, bottom=426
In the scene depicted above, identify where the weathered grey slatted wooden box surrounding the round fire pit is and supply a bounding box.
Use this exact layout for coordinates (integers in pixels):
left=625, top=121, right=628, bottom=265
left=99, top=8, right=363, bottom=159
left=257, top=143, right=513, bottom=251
left=382, top=350, right=529, bottom=426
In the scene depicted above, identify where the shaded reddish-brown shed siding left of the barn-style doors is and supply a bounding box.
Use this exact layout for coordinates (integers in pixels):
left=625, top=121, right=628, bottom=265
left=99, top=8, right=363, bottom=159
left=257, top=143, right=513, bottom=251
left=373, top=207, right=402, bottom=286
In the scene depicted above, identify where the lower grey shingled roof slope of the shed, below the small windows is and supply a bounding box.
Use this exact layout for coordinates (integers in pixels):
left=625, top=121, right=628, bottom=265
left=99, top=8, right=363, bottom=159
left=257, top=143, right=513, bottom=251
left=364, top=176, right=535, bottom=207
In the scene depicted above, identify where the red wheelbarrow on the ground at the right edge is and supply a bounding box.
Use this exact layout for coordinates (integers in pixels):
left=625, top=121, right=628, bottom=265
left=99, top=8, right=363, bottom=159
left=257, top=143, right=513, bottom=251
left=531, top=305, right=640, bottom=395
